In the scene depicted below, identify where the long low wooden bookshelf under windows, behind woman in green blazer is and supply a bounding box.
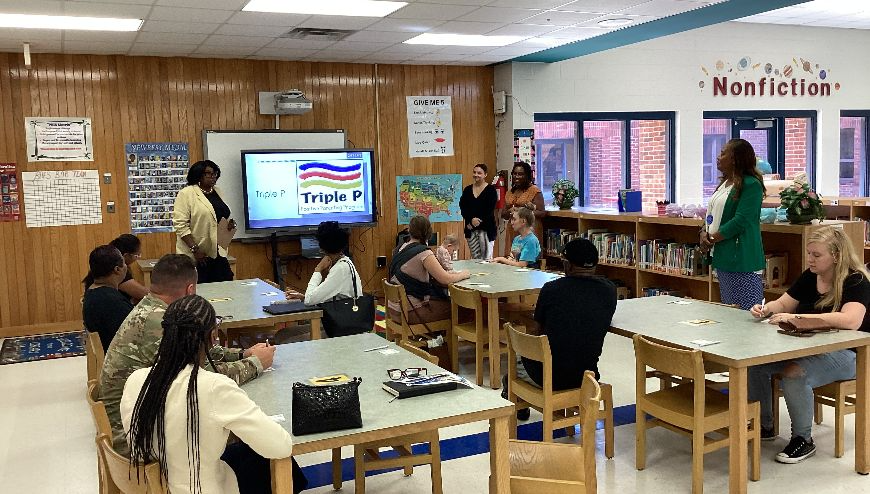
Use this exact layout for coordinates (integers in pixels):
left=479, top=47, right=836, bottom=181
left=541, top=206, right=870, bottom=301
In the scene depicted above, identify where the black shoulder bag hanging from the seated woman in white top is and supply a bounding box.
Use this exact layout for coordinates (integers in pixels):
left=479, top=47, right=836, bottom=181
left=319, top=259, right=375, bottom=338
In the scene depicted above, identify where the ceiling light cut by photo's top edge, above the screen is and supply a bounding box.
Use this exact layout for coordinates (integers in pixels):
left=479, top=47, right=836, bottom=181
left=242, top=0, right=408, bottom=17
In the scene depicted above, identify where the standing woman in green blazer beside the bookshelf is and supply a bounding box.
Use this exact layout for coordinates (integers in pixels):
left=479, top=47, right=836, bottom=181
left=700, top=139, right=765, bottom=310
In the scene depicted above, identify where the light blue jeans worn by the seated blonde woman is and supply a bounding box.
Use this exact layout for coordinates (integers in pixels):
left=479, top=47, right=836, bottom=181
left=748, top=350, right=856, bottom=439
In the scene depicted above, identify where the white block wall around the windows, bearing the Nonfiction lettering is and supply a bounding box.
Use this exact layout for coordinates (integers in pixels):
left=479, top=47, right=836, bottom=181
left=495, top=22, right=870, bottom=203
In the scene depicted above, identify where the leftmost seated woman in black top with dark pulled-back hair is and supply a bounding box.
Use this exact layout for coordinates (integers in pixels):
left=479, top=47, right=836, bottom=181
left=82, top=245, right=133, bottom=349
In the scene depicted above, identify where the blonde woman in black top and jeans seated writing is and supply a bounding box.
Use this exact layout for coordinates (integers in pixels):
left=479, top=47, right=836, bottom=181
left=749, top=227, right=870, bottom=463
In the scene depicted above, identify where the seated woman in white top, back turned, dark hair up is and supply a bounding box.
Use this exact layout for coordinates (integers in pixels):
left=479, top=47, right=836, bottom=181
left=286, top=221, right=363, bottom=305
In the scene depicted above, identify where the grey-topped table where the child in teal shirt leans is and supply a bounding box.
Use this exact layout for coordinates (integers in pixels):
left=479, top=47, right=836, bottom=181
left=453, top=260, right=562, bottom=389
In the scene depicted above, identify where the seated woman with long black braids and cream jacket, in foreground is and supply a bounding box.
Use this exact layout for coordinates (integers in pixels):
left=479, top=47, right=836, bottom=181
left=121, top=295, right=306, bottom=494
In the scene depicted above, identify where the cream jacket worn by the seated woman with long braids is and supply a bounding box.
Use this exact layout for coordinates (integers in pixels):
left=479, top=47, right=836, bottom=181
left=121, top=366, right=293, bottom=494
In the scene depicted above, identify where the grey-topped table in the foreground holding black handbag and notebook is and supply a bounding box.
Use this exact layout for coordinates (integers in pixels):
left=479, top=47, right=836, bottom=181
left=245, top=333, right=514, bottom=494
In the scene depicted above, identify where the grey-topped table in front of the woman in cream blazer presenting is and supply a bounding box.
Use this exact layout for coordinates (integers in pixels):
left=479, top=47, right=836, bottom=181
left=196, top=278, right=323, bottom=340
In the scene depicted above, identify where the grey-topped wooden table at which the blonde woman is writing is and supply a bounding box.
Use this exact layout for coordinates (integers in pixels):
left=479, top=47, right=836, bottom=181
left=610, top=295, right=870, bottom=493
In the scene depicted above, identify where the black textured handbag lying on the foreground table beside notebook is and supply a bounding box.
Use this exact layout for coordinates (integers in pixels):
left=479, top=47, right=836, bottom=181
left=292, top=377, right=362, bottom=436
